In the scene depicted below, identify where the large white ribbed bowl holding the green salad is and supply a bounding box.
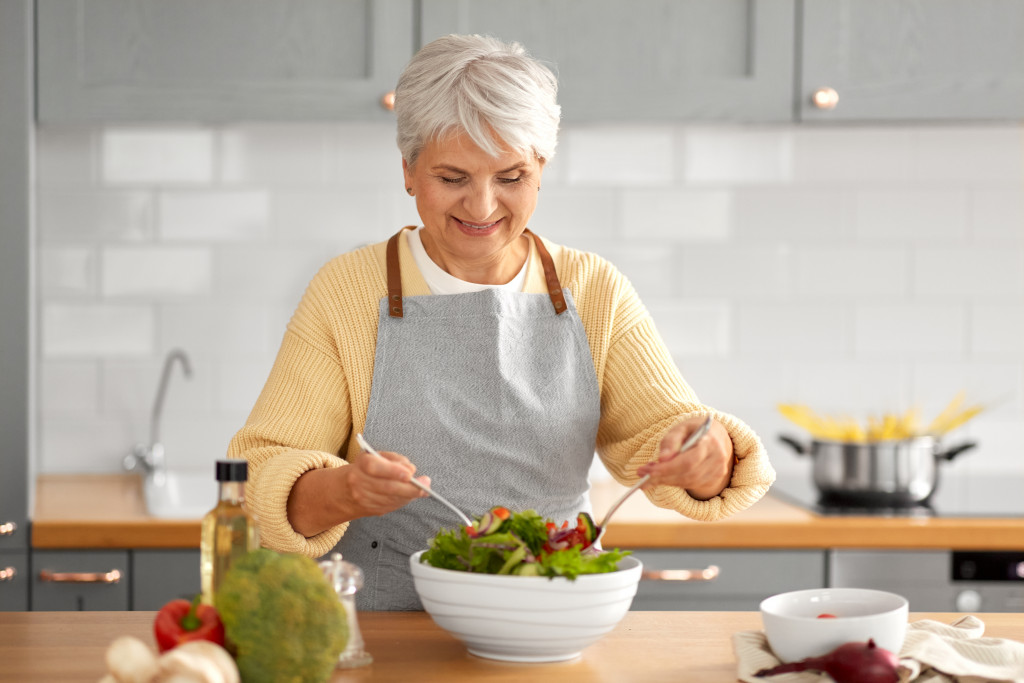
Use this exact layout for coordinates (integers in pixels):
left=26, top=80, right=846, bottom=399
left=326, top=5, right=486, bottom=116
left=410, top=550, right=643, bottom=661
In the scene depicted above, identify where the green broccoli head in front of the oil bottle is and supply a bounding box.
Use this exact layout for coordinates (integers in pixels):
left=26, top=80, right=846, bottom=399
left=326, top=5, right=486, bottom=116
left=214, top=548, right=348, bottom=683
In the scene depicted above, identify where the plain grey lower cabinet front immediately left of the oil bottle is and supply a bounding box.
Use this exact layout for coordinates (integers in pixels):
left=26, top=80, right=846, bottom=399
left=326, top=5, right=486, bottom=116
left=131, top=550, right=200, bottom=611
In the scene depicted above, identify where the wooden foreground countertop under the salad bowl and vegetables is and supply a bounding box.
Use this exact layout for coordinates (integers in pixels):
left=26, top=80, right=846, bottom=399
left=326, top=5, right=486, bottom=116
left=0, top=612, right=1024, bottom=683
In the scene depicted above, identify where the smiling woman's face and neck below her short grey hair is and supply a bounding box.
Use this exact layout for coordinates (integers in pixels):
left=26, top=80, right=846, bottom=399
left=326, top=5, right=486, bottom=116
left=402, top=134, right=544, bottom=284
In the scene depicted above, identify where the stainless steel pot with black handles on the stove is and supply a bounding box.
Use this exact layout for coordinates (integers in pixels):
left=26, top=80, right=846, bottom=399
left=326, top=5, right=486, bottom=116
left=779, top=435, right=977, bottom=507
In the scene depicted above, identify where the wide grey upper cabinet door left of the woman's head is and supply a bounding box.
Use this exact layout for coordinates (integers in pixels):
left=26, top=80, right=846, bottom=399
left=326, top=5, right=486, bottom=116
left=38, top=0, right=414, bottom=122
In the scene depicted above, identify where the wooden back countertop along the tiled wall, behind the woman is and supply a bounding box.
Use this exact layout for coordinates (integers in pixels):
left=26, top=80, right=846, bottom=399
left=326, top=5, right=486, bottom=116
left=32, top=474, right=1024, bottom=550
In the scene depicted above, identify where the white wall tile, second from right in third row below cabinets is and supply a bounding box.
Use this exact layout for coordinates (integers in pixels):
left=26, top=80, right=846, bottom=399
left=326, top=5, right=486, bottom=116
left=795, top=247, right=910, bottom=301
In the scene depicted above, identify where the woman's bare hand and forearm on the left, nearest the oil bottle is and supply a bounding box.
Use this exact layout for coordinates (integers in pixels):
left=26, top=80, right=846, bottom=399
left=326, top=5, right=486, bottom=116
left=288, top=451, right=430, bottom=539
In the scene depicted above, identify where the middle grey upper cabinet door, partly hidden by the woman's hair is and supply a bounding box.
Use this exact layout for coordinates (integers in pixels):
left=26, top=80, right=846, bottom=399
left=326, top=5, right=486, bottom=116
left=421, top=0, right=795, bottom=122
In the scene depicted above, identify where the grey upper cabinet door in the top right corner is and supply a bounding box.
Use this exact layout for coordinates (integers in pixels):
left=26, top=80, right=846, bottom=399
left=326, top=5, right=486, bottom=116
left=799, top=0, right=1024, bottom=121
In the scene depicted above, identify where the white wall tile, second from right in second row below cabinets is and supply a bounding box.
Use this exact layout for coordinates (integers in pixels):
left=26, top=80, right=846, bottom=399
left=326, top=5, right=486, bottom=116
left=856, top=188, right=967, bottom=245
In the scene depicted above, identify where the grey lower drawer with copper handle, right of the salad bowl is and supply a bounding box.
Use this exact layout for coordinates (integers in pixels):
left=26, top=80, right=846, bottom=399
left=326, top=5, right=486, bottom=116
left=632, top=549, right=825, bottom=611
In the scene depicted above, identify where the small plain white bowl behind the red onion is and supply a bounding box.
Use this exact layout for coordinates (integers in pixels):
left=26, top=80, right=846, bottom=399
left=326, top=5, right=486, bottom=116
left=761, top=588, right=908, bottom=661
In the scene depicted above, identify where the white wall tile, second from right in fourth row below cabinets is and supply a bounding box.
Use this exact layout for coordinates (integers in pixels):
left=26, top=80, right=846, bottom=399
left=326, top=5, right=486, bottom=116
left=854, top=303, right=967, bottom=360
